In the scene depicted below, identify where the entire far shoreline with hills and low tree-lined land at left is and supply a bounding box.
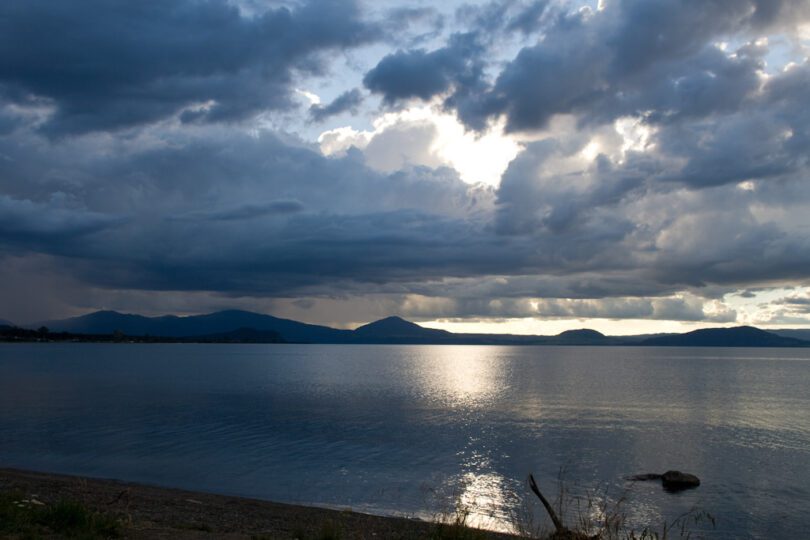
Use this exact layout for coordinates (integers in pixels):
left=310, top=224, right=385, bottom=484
left=0, top=312, right=810, bottom=348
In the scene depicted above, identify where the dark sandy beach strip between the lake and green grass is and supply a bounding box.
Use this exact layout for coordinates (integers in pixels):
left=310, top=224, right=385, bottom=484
left=0, top=469, right=514, bottom=540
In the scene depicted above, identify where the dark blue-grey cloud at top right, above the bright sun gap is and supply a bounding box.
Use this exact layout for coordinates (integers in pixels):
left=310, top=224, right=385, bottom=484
left=474, top=1, right=776, bottom=130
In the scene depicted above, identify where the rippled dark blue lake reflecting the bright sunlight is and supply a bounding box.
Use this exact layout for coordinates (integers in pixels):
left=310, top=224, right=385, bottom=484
left=0, top=344, right=810, bottom=538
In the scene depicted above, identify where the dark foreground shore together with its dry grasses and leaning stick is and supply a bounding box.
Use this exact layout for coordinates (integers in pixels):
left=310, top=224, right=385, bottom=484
left=0, top=468, right=715, bottom=540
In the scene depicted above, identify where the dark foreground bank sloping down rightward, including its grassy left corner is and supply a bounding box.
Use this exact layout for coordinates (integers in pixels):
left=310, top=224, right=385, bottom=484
left=0, top=469, right=514, bottom=540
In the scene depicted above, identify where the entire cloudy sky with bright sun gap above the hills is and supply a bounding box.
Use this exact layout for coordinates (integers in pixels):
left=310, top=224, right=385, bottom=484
left=0, top=0, right=810, bottom=334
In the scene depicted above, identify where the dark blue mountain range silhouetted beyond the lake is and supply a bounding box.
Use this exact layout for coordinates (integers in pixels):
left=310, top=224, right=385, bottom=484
left=23, top=310, right=810, bottom=347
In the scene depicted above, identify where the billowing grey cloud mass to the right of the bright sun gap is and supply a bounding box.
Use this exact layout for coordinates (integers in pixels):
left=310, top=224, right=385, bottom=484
left=486, top=99, right=810, bottom=297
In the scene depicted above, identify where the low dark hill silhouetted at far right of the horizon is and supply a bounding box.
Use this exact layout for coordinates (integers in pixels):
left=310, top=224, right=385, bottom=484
left=641, top=326, right=810, bottom=347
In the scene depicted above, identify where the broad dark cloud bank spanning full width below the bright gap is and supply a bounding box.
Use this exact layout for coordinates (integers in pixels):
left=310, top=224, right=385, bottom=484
left=0, top=106, right=810, bottom=320
